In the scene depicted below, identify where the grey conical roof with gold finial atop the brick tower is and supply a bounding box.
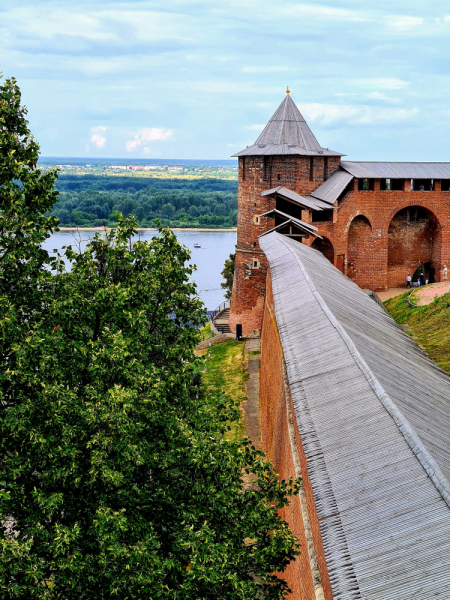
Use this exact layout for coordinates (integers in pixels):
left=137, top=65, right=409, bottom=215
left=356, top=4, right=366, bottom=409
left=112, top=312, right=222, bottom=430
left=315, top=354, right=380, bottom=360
left=233, top=89, right=343, bottom=156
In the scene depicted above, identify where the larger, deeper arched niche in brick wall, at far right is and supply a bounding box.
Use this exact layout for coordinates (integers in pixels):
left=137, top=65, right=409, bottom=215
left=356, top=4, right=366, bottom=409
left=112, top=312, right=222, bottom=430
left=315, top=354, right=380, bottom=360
left=387, top=206, right=441, bottom=287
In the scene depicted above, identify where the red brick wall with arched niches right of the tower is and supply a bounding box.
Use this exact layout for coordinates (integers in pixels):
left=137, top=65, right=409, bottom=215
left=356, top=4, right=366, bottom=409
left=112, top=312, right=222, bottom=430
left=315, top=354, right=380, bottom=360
left=306, top=186, right=450, bottom=291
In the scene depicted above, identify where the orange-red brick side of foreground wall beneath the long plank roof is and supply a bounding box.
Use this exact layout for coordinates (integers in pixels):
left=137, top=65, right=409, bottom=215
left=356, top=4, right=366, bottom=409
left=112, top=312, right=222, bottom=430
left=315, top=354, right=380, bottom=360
left=260, top=272, right=332, bottom=600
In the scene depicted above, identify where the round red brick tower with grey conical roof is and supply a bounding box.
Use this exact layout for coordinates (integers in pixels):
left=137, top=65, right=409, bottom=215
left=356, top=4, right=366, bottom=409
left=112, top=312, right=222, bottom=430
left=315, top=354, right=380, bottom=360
left=229, top=89, right=342, bottom=336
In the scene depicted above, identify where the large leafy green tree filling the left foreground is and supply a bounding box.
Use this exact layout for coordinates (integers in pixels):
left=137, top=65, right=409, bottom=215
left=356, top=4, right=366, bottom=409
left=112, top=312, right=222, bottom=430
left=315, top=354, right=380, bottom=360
left=0, top=80, right=298, bottom=600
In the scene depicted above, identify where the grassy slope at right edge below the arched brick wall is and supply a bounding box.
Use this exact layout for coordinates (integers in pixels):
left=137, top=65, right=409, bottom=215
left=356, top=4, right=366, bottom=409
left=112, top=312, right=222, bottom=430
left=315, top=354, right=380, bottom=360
left=384, top=293, right=450, bottom=374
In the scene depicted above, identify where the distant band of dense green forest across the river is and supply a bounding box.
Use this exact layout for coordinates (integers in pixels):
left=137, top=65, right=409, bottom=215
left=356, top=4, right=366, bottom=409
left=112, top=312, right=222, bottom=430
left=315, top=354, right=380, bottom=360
left=51, top=175, right=237, bottom=228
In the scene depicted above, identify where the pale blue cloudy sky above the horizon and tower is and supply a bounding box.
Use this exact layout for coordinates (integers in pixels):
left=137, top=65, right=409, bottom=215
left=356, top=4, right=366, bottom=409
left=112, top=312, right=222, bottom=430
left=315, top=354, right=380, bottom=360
left=0, top=0, right=450, bottom=161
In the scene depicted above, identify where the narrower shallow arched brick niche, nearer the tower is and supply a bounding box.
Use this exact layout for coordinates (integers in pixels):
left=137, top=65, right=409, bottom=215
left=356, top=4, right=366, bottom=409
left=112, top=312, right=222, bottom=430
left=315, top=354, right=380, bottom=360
left=347, top=215, right=373, bottom=288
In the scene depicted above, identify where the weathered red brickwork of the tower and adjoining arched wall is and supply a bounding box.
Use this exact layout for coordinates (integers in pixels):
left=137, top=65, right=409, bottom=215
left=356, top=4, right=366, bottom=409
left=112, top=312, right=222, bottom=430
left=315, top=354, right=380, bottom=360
left=230, top=155, right=450, bottom=335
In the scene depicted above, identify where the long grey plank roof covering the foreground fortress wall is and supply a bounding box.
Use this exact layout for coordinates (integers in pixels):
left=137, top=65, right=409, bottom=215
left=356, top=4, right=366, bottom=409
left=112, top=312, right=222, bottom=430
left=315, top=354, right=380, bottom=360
left=260, top=232, right=450, bottom=600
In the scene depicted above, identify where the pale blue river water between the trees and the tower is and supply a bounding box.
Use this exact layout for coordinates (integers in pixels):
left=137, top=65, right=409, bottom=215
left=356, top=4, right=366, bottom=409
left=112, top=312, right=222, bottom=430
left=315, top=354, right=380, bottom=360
left=44, top=231, right=236, bottom=310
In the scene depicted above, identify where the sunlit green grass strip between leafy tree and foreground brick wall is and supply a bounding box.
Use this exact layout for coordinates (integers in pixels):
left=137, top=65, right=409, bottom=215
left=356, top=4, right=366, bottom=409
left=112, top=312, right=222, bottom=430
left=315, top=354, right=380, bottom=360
left=202, top=340, right=248, bottom=440
